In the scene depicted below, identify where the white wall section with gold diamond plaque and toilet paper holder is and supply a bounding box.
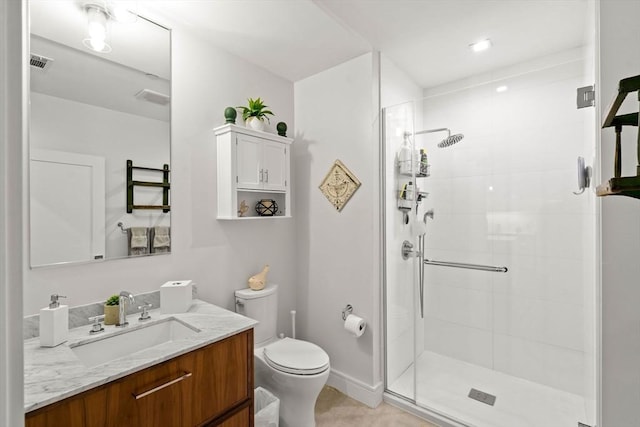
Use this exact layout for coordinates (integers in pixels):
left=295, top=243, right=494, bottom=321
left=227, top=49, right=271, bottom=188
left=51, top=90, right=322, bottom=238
left=292, top=54, right=380, bottom=401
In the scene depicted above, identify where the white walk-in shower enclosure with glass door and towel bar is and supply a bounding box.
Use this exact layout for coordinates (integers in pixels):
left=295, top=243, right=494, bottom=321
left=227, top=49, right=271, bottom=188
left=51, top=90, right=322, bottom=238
left=382, top=4, right=597, bottom=427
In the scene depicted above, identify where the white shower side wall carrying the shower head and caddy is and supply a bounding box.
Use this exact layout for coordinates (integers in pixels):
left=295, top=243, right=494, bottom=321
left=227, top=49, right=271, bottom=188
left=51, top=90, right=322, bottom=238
left=381, top=55, right=423, bottom=390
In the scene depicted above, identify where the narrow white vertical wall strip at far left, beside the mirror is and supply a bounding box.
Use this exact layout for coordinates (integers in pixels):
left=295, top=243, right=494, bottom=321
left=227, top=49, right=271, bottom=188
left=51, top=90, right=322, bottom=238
left=0, top=1, right=27, bottom=427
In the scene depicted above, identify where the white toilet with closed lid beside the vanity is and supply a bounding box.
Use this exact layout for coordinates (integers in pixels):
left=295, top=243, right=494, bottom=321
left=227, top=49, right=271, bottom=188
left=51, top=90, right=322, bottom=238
left=235, top=285, right=330, bottom=427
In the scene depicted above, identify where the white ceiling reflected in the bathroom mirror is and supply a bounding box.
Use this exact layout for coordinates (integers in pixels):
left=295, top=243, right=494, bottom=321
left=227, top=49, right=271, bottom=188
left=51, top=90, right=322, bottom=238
left=29, top=0, right=171, bottom=121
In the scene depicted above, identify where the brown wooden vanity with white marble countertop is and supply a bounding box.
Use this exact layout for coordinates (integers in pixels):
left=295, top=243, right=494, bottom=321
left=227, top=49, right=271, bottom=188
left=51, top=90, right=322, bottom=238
left=25, top=302, right=255, bottom=427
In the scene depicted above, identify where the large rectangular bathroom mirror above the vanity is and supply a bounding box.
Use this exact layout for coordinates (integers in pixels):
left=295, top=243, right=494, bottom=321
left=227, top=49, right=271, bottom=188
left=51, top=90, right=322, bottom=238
left=29, top=0, right=171, bottom=267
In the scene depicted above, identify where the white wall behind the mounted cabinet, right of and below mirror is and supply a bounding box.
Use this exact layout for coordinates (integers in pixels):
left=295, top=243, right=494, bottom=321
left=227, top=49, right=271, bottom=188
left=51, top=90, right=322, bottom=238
left=24, top=21, right=296, bottom=342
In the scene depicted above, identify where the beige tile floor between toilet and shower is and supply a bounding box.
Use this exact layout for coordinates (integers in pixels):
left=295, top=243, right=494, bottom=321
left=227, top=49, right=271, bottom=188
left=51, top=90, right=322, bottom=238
left=316, top=386, right=437, bottom=427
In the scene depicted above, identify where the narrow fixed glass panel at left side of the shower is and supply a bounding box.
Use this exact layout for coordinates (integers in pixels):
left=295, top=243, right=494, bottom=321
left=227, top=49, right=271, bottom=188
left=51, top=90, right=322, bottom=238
left=383, top=102, right=423, bottom=402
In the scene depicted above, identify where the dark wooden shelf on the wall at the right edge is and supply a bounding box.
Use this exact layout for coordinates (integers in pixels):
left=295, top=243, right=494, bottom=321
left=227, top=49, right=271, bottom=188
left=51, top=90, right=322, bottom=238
left=596, top=75, right=640, bottom=199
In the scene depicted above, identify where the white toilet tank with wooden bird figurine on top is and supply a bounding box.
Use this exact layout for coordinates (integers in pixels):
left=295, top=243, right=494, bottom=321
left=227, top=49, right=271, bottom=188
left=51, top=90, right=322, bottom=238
left=235, top=285, right=278, bottom=346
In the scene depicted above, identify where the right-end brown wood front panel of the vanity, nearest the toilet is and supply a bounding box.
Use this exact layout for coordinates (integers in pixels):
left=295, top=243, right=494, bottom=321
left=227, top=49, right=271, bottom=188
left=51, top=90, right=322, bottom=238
left=191, top=331, right=253, bottom=425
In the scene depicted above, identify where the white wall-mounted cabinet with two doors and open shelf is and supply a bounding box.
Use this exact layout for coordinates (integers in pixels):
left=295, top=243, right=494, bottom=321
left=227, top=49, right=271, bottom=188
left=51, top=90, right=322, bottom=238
left=214, top=124, right=293, bottom=219
